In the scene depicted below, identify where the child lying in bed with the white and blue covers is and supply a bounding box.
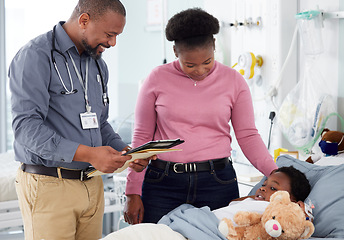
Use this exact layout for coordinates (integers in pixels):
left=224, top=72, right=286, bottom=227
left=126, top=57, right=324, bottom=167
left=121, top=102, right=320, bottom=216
left=104, top=166, right=311, bottom=240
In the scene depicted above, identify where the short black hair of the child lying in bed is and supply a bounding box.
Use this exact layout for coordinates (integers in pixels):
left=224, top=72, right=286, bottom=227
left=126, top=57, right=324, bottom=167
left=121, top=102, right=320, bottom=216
left=275, top=166, right=311, bottom=202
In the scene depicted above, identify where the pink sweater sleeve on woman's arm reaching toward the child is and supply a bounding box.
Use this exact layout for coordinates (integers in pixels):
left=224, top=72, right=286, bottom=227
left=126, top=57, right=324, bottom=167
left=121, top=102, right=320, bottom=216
left=231, top=73, right=277, bottom=176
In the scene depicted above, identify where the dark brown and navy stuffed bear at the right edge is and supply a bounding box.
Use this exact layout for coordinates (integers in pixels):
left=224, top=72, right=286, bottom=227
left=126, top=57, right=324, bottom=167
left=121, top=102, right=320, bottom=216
left=306, top=128, right=344, bottom=163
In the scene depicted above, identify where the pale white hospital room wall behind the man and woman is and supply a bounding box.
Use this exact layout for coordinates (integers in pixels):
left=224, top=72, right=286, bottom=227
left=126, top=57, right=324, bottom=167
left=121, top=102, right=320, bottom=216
left=111, top=0, right=344, bottom=155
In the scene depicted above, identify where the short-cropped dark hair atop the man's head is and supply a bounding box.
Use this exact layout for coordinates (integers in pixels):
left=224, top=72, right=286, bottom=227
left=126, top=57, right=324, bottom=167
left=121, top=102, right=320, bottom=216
left=72, top=0, right=126, bottom=20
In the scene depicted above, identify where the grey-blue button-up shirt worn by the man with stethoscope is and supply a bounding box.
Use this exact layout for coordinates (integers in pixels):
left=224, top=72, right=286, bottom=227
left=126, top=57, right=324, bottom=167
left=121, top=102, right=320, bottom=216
left=8, top=22, right=126, bottom=169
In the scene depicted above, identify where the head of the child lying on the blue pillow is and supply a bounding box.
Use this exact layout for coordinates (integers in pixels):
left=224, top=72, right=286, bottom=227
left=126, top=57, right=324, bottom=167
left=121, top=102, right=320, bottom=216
left=255, top=166, right=311, bottom=202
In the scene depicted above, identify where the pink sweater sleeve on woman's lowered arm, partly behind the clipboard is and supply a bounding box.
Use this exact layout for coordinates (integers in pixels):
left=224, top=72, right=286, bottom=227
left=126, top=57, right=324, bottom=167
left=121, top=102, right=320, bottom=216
left=126, top=72, right=156, bottom=195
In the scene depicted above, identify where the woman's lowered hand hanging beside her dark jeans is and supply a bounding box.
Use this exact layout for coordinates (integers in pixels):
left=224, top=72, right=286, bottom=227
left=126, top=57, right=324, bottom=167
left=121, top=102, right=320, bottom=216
left=123, top=194, right=144, bottom=224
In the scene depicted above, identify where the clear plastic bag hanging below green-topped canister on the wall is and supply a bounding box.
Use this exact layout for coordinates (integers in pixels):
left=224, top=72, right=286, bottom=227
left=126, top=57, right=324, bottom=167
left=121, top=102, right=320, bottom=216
left=278, top=8, right=342, bottom=154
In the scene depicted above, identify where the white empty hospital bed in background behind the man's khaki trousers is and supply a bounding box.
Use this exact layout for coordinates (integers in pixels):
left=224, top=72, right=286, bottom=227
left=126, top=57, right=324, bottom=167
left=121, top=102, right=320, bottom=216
left=0, top=152, right=126, bottom=239
